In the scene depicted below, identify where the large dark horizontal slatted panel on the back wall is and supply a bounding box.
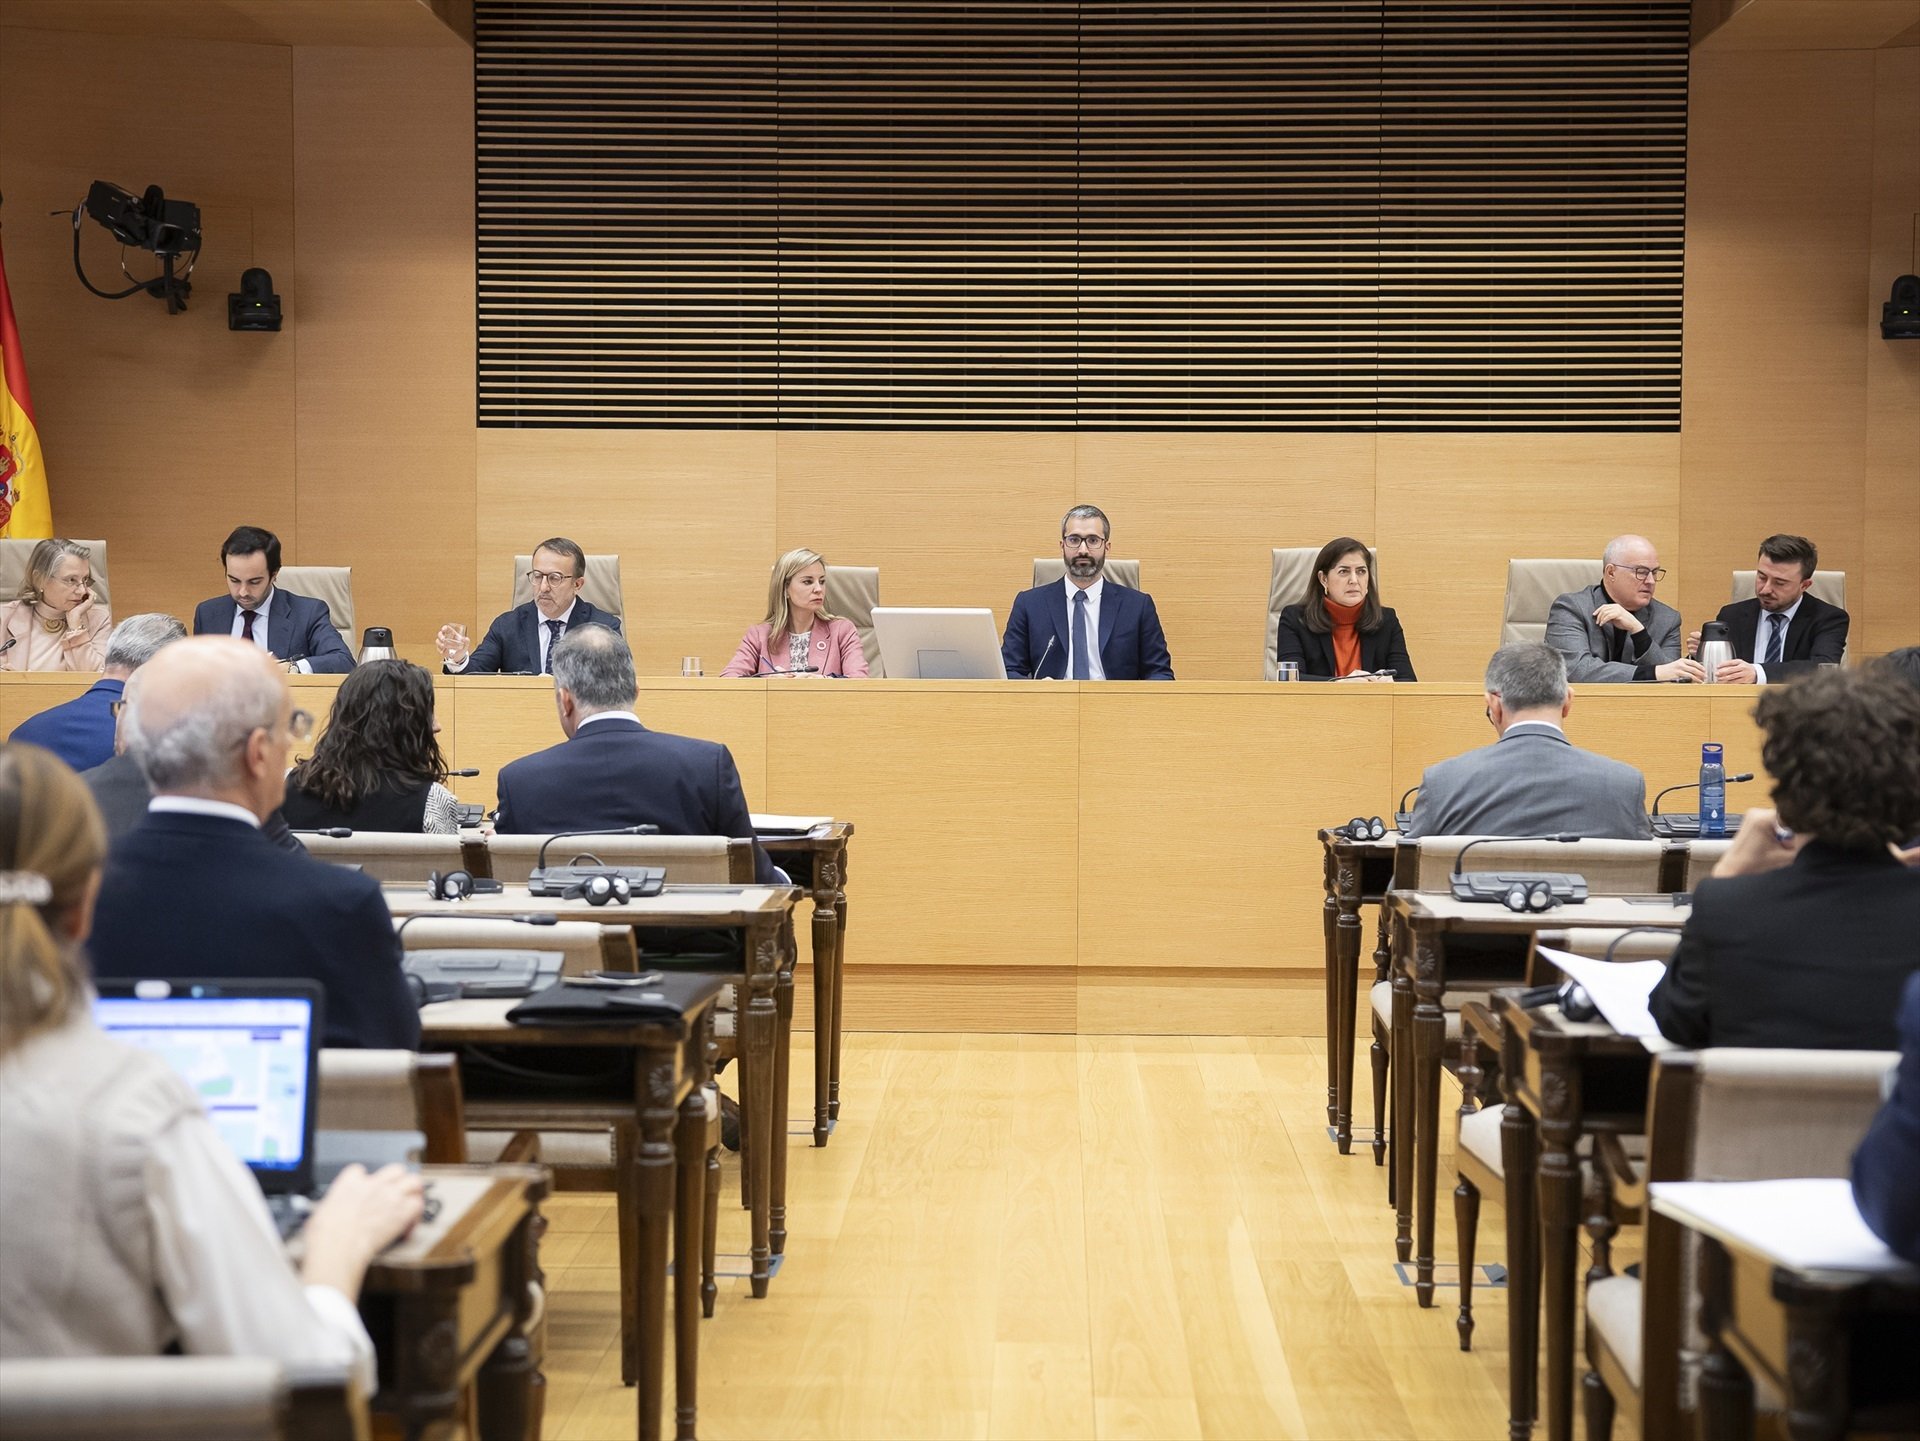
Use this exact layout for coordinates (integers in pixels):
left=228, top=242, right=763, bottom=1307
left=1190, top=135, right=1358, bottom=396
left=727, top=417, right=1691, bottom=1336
left=476, top=0, right=1688, bottom=432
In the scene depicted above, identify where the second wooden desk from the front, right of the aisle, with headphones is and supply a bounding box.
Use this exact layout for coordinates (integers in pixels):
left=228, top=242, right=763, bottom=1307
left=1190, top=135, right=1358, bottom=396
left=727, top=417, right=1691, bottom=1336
left=1386, top=890, right=1688, bottom=1307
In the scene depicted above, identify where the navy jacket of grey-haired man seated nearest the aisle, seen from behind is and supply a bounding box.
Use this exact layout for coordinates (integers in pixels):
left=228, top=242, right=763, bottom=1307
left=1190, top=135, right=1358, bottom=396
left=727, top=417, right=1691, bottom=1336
left=493, top=720, right=780, bottom=885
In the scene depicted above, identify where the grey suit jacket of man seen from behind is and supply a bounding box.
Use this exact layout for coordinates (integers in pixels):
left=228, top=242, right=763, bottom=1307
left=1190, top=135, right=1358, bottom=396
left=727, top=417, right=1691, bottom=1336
left=1405, top=721, right=1653, bottom=840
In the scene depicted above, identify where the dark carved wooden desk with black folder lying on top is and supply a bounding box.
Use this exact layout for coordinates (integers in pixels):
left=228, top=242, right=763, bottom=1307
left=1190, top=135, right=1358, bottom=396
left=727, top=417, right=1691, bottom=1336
left=420, top=988, right=721, bottom=1441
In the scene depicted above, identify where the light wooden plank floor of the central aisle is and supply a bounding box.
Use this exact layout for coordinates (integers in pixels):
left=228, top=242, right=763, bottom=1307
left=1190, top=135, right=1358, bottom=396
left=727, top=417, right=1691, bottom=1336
left=543, top=1034, right=1630, bottom=1441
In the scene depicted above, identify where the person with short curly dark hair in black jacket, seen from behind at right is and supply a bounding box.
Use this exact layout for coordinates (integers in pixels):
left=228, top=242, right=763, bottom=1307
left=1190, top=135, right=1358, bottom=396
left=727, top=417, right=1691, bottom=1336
left=1647, top=668, right=1920, bottom=1051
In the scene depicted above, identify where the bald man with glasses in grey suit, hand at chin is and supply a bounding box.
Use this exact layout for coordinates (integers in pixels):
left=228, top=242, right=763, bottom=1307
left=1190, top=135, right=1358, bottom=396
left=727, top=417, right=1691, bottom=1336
left=1548, top=535, right=1707, bottom=681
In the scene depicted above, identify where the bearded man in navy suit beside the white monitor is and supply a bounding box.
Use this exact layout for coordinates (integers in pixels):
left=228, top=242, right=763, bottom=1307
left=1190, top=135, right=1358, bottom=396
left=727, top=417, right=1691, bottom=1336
left=1000, top=505, right=1173, bottom=681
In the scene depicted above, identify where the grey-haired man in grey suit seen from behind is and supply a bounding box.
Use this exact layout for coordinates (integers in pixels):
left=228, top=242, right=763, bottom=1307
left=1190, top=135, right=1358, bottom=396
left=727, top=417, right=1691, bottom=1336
left=1405, top=645, right=1653, bottom=840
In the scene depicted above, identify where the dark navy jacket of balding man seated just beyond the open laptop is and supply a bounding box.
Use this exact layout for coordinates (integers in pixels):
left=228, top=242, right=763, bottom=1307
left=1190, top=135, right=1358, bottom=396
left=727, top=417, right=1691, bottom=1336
left=86, top=812, right=426, bottom=1050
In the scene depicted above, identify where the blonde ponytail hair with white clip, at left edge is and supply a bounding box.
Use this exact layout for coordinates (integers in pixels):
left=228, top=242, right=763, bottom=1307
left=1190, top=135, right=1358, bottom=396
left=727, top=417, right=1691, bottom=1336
left=0, top=744, right=108, bottom=1055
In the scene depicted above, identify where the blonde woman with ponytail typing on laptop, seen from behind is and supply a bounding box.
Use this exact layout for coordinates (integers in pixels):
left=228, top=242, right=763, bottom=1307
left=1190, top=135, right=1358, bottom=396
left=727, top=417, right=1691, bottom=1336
left=0, top=744, right=420, bottom=1391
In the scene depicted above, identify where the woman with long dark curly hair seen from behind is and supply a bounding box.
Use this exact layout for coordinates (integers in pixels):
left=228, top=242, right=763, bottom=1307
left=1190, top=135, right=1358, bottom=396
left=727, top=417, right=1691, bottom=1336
left=286, top=660, right=459, bottom=835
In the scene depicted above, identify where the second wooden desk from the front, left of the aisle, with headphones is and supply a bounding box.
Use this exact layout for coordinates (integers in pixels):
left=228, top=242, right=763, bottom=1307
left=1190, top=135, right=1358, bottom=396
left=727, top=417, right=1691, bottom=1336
left=386, top=886, right=801, bottom=1297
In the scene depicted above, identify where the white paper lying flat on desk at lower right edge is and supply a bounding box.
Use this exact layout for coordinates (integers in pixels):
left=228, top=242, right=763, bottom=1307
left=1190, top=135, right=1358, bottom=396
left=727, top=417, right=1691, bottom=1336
left=1649, top=1178, right=1920, bottom=1276
